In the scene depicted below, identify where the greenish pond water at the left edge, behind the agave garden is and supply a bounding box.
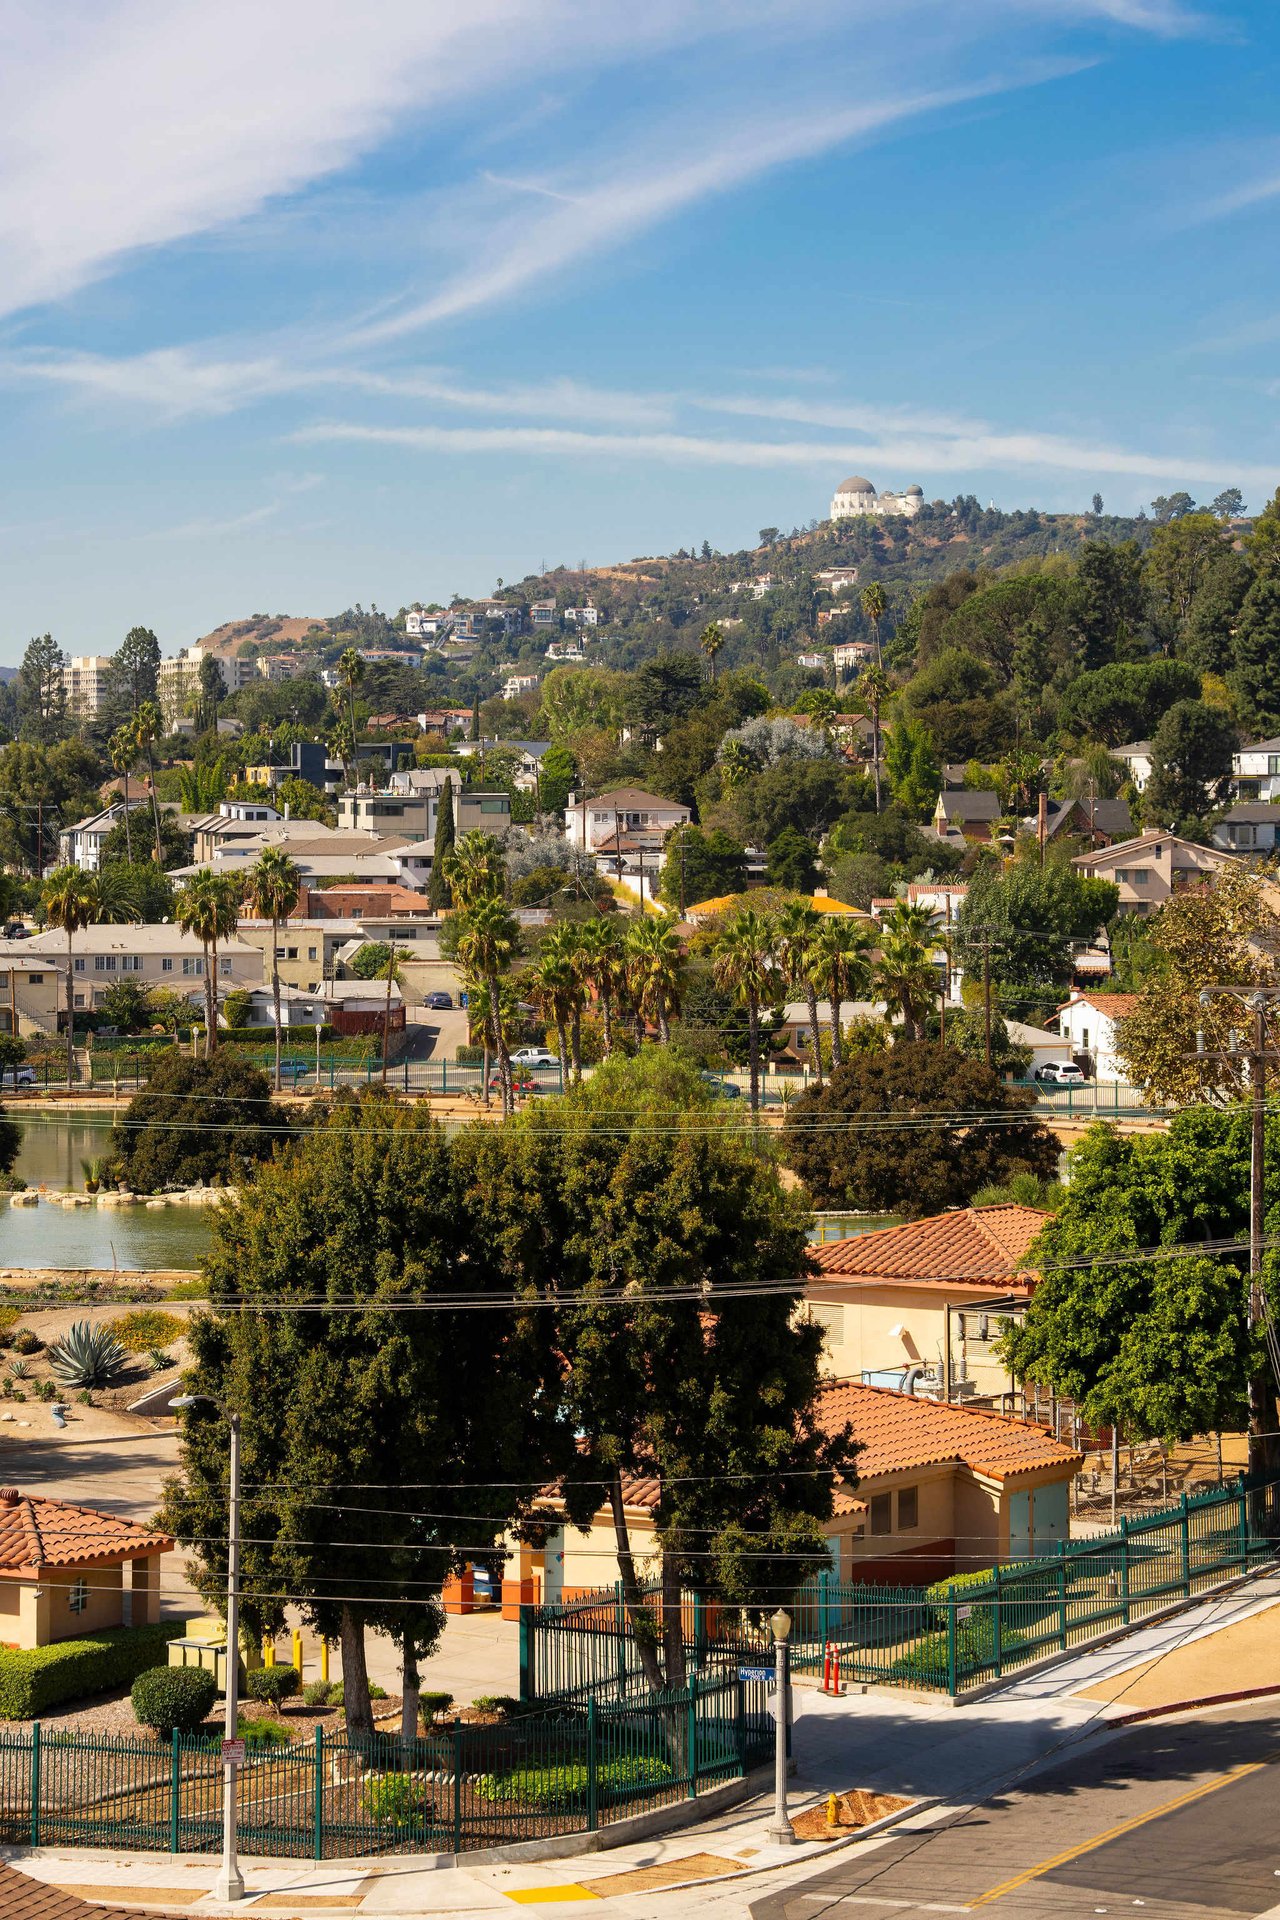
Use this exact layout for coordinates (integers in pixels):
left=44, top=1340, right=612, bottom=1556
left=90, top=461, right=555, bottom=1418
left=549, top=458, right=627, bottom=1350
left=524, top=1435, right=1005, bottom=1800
left=0, top=1106, right=209, bottom=1273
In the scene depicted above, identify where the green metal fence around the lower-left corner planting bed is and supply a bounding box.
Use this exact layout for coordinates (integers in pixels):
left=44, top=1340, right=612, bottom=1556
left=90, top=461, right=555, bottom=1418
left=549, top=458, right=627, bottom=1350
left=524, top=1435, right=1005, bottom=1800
left=0, top=1678, right=773, bottom=1860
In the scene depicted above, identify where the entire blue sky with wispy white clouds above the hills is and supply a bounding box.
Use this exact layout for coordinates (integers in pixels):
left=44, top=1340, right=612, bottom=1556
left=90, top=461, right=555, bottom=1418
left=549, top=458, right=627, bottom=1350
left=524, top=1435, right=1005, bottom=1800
left=0, top=0, right=1280, bottom=662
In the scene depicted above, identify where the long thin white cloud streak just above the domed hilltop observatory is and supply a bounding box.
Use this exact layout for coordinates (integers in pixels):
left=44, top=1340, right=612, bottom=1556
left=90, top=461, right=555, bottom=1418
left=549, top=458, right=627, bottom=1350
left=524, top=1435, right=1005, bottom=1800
left=294, top=422, right=1274, bottom=486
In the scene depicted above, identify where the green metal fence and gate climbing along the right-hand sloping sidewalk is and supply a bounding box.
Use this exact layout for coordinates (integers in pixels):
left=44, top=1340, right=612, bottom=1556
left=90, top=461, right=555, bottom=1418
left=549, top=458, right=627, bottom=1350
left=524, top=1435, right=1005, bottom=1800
left=520, top=1475, right=1280, bottom=1701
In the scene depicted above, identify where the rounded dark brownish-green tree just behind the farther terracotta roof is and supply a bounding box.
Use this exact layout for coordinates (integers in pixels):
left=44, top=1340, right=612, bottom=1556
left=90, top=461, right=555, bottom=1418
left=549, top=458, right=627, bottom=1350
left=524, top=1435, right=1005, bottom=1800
left=783, top=1041, right=1057, bottom=1217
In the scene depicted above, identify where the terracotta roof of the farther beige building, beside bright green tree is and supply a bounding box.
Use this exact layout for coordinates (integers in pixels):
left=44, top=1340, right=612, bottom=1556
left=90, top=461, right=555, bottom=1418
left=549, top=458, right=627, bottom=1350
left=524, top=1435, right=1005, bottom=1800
left=812, top=1206, right=1050, bottom=1290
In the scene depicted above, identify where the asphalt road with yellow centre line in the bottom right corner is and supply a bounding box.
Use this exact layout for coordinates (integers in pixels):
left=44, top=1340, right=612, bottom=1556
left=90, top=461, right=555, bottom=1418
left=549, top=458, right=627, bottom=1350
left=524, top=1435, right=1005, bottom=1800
left=750, top=1701, right=1280, bottom=1920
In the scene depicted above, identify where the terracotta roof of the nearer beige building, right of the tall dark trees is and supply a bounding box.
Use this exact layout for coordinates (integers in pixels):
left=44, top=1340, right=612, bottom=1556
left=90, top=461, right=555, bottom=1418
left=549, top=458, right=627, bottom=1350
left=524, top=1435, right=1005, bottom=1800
left=818, top=1380, right=1080, bottom=1492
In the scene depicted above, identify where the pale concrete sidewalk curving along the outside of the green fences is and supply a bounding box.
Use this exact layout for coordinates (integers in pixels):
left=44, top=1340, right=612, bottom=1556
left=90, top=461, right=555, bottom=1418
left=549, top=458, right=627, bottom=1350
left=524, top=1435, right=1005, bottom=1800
left=10, top=1572, right=1280, bottom=1920
